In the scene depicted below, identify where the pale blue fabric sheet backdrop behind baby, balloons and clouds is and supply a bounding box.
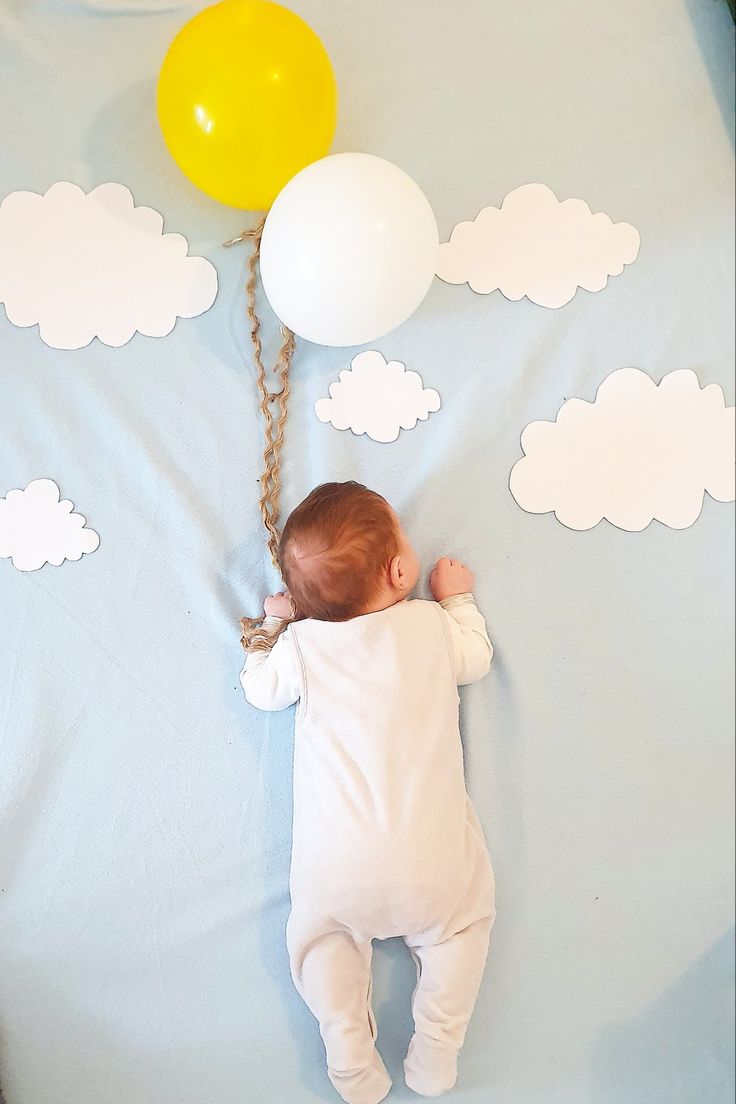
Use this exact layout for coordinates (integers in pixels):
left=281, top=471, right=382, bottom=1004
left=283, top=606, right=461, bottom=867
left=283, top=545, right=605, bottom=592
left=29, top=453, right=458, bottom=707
left=0, top=0, right=734, bottom=1104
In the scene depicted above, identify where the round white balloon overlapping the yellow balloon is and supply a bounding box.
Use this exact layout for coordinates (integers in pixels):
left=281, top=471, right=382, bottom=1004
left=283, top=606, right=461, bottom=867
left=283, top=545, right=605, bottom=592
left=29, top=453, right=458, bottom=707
left=260, top=153, right=439, bottom=346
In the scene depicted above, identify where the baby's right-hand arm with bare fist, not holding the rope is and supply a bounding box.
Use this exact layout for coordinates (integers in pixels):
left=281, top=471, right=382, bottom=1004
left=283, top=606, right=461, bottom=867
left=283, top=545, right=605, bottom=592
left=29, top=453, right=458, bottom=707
left=429, top=556, right=493, bottom=686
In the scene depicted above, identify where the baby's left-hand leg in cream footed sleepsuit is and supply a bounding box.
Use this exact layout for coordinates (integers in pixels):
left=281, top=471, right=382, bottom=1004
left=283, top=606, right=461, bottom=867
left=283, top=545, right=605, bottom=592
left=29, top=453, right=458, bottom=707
left=287, top=912, right=391, bottom=1104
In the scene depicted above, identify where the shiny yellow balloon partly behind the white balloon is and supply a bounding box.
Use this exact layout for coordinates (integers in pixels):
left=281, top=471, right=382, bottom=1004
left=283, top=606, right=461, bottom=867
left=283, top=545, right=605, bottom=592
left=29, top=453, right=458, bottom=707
left=158, top=0, right=338, bottom=210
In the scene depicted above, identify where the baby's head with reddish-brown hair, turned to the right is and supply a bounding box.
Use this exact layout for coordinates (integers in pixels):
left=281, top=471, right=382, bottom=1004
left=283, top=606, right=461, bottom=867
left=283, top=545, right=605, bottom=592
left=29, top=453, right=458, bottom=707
left=279, top=481, right=419, bottom=620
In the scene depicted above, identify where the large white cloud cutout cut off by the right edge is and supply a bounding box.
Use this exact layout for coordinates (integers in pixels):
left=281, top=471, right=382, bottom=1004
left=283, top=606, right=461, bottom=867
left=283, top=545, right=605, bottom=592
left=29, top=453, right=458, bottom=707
left=509, top=368, right=736, bottom=532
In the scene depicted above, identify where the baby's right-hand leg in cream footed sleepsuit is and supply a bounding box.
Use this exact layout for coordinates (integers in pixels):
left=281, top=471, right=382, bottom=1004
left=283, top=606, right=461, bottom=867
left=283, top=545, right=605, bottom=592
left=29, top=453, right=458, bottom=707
left=404, top=916, right=493, bottom=1096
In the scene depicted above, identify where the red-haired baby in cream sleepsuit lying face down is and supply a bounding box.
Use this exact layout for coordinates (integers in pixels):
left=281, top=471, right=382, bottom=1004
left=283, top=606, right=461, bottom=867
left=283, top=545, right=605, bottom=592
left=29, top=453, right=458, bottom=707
left=241, top=482, right=494, bottom=1104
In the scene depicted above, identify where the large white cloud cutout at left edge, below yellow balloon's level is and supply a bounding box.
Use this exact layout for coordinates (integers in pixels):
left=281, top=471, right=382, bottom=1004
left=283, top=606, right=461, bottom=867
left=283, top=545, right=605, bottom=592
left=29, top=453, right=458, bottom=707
left=0, top=181, right=217, bottom=349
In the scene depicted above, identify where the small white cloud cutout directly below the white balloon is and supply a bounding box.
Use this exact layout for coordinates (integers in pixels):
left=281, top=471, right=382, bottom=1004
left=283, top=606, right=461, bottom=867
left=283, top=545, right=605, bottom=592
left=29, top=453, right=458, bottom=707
left=314, top=349, right=440, bottom=444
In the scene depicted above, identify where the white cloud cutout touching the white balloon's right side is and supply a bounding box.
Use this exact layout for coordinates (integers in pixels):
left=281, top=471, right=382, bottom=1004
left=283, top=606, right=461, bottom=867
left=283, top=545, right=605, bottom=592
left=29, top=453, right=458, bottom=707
left=437, top=184, right=639, bottom=307
